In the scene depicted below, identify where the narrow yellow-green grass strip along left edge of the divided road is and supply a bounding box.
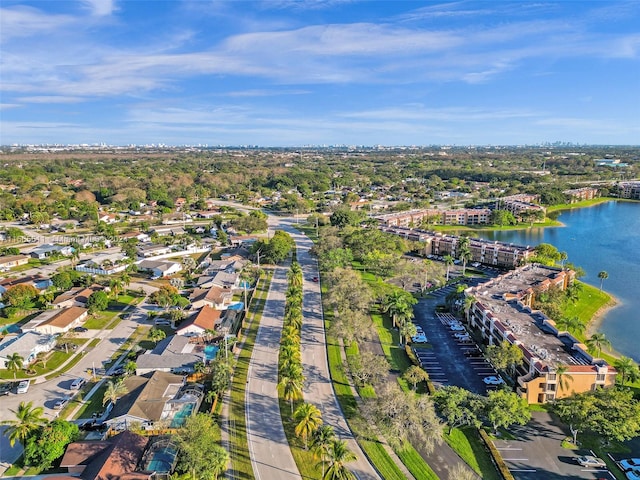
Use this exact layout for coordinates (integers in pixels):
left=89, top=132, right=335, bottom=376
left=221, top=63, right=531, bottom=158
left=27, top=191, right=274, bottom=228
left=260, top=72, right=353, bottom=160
left=229, top=270, right=273, bottom=479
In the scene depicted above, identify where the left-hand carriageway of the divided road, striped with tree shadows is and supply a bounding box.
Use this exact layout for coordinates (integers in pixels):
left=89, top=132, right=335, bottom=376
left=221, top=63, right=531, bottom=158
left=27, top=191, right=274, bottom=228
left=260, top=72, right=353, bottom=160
left=245, top=267, right=302, bottom=480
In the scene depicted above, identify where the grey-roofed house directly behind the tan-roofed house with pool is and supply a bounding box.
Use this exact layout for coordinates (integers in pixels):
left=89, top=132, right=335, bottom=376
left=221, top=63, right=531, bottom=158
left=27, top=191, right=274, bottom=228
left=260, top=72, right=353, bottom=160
left=136, top=335, right=205, bottom=375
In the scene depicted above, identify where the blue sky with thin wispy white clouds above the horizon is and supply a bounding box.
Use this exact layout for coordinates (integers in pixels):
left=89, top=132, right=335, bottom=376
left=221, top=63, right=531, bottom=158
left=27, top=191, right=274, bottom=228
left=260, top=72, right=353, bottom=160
left=0, top=0, right=640, bottom=146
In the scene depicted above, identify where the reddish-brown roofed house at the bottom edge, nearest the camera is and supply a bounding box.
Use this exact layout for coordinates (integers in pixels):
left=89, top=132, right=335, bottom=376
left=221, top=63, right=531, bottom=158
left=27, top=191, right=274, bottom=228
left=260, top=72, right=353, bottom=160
left=60, top=430, right=150, bottom=480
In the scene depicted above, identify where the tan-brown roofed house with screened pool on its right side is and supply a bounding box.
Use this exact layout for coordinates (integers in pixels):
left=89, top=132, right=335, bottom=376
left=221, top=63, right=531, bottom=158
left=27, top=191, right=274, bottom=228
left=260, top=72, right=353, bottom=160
left=105, top=371, right=202, bottom=431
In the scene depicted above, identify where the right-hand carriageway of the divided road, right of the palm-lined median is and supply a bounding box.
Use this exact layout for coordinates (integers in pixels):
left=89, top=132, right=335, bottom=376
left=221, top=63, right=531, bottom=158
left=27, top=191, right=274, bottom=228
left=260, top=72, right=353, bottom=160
left=280, top=224, right=381, bottom=480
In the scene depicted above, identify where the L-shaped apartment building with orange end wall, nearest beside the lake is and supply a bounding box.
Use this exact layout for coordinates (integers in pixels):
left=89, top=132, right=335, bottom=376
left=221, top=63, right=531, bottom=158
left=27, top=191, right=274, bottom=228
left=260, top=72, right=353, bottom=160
left=465, top=264, right=616, bottom=403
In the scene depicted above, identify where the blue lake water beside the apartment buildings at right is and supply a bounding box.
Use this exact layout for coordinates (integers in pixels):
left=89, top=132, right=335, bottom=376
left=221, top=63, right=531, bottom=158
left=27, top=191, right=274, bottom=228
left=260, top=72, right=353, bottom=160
left=479, top=201, right=640, bottom=362
